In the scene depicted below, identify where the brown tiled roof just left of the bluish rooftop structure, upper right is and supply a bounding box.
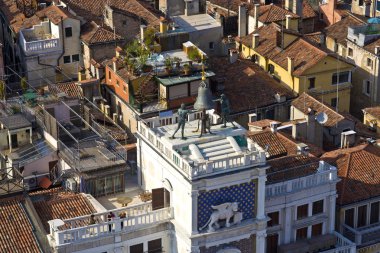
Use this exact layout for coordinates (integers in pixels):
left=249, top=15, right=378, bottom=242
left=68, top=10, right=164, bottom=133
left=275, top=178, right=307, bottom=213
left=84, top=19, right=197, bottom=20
left=325, top=15, right=365, bottom=46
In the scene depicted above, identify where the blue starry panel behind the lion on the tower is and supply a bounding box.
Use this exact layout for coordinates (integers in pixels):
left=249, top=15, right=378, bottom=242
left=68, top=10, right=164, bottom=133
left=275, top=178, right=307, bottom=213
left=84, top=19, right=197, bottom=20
left=198, top=181, right=256, bottom=228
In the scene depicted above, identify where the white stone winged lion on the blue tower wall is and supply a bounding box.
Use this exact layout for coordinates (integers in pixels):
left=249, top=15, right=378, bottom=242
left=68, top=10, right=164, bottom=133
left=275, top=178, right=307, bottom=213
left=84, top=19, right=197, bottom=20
left=200, top=202, right=239, bottom=232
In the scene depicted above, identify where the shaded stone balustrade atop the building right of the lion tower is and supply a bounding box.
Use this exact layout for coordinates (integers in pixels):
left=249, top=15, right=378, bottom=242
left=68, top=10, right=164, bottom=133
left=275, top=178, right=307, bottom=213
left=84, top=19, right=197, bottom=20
left=265, top=161, right=338, bottom=198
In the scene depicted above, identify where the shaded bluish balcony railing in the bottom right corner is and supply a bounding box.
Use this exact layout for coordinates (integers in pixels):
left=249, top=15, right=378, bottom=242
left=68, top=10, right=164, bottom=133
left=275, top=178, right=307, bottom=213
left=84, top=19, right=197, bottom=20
left=343, top=223, right=380, bottom=246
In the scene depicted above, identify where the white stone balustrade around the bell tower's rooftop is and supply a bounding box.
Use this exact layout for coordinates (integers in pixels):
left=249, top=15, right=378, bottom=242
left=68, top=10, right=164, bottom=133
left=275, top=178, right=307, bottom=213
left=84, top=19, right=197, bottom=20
left=138, top=121, right=266, bottom=179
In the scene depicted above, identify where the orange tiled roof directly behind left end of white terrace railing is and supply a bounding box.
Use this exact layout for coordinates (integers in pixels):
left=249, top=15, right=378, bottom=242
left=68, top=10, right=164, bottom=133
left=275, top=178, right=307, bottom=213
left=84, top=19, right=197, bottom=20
left=30, top=188, right=96, bottom=232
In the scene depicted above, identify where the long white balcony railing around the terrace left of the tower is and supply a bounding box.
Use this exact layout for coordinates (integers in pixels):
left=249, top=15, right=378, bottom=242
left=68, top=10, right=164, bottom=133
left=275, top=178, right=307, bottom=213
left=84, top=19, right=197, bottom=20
left=50, top=202, right=173, bottom=246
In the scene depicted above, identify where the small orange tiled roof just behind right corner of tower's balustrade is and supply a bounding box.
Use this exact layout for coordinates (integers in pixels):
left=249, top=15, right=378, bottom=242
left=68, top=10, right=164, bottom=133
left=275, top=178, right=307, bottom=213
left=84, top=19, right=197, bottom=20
left=248, top=131, right=287, bottom=159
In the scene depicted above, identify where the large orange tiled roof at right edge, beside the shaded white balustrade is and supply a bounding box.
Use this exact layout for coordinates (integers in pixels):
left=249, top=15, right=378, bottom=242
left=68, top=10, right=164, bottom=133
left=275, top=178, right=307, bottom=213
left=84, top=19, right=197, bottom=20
left=322, top=144, right=380, bottom=205
